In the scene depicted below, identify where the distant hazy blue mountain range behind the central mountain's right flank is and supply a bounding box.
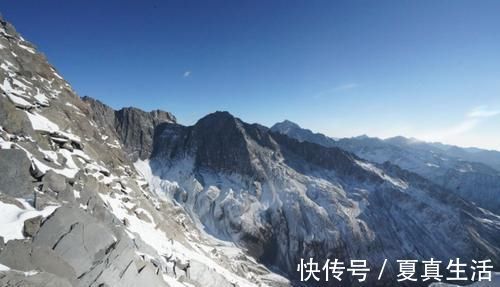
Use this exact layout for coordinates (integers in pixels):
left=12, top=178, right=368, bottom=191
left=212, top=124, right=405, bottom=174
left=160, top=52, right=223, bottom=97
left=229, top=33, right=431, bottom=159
left=272, top=120, right=500, bottom=214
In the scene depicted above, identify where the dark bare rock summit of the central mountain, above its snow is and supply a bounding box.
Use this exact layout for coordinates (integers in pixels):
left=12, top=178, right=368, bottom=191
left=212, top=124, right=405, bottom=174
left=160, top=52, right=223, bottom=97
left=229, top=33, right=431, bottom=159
left=152, top=112, right=274, bottom=180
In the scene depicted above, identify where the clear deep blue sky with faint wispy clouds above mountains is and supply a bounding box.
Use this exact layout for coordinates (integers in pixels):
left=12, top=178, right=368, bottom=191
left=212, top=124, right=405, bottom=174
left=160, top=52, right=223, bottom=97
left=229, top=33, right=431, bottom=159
left=0, top=0, right=500, bottom=150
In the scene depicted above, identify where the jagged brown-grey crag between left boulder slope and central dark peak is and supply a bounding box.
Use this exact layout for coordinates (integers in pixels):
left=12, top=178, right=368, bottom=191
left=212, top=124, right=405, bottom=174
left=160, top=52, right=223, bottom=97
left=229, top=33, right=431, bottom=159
left=82, top=96, right=176, bottom=161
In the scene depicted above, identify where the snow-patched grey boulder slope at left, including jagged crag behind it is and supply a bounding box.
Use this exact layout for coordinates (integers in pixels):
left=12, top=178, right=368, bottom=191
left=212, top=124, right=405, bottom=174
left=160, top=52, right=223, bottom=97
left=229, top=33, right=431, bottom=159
left=0, top=15, right=287, bottom=286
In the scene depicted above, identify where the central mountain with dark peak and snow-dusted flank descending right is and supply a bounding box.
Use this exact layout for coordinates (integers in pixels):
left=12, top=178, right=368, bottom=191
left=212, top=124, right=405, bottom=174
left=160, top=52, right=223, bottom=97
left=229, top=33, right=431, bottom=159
left=142, top=112, right=500, bottom=286
